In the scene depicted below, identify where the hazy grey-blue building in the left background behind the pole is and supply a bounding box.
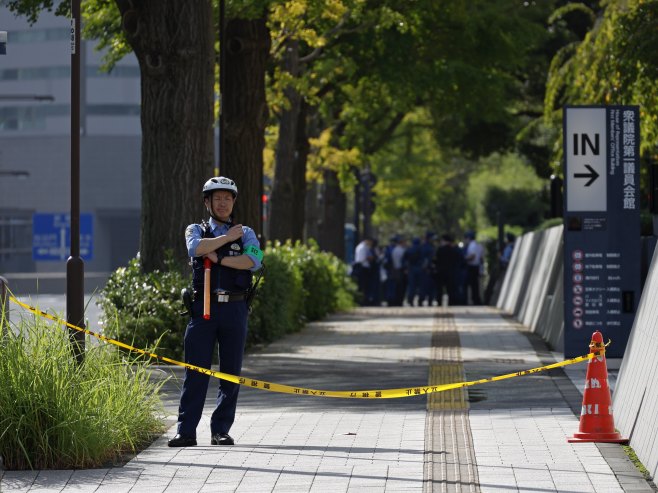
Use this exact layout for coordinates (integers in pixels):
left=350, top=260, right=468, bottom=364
left=0, top=5, right=141, bottom=290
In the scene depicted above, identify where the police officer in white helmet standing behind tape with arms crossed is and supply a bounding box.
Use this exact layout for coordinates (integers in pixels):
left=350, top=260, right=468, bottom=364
left=169, top=176, right=262, bottom=447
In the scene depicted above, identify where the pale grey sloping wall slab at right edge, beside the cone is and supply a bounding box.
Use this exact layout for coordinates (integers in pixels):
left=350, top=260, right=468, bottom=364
left=613, top=242, right=658, bottom=478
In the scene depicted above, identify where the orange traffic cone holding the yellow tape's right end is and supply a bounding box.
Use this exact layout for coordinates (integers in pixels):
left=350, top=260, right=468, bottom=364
left=569, top=330, right=628, bottom=443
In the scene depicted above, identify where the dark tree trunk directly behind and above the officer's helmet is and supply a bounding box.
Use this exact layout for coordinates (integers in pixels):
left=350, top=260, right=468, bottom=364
left=220, top=17, right=270, bottom=239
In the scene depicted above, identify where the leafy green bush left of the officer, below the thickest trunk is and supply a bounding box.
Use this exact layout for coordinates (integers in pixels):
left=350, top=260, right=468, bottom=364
left=99, top=253, right=189, bottom=357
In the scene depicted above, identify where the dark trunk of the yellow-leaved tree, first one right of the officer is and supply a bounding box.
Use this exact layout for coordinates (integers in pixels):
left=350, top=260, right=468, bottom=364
left=270, top=40, right=306, bottom=241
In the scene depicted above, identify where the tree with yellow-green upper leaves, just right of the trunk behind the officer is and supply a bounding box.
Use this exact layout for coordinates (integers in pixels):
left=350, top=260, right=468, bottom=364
left=262, top=0, right=374, bottom=240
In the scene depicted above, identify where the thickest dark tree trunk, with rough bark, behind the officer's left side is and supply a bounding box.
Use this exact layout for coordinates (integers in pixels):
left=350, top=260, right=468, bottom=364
left=116, top=0, right=214, bottom=272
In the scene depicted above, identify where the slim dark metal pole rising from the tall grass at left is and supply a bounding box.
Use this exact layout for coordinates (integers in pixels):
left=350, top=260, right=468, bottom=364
left=66, top=0, right=85, bottom=363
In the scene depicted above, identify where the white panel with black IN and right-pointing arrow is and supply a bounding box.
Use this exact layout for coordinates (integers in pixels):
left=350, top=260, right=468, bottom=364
left=564, top=108, right=608, bottom=212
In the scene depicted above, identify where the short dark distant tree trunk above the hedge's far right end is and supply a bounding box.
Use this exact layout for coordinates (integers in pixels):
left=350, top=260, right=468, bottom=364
left=318, top=171, right=347, bottom=259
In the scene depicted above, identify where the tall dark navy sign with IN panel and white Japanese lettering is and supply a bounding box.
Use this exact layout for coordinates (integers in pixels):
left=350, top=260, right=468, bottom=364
left=563, top=106, right=641, bottom=358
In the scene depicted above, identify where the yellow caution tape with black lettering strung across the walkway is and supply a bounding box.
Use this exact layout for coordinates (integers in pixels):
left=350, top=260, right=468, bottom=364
left=9, top=296, right=602, bottom=399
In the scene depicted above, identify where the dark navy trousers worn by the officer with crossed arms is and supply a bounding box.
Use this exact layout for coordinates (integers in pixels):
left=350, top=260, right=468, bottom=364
left=178, top=299, right=248, bottom=437
